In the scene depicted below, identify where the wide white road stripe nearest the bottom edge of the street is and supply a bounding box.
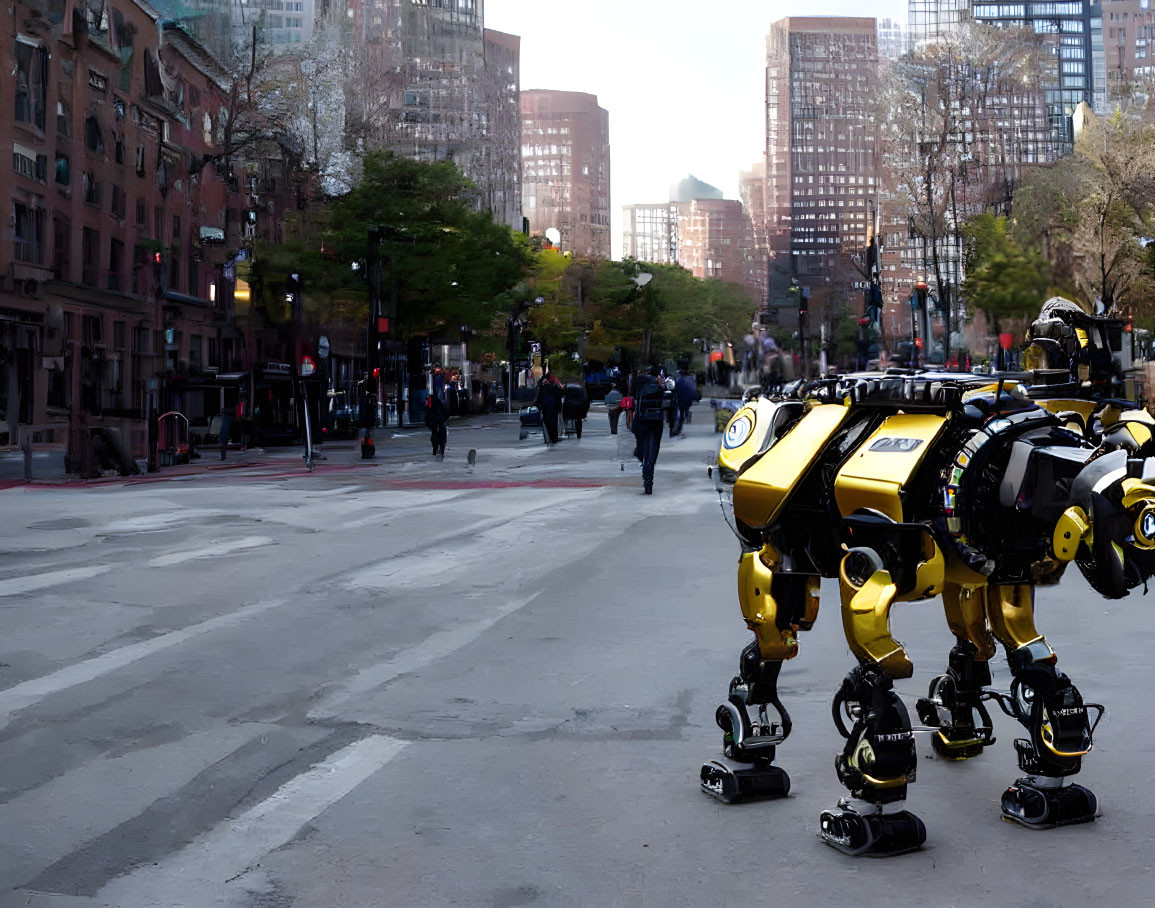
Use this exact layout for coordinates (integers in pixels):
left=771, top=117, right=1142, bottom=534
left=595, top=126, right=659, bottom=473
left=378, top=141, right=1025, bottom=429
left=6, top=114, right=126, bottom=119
left=96, top=735, right=407, bottom=908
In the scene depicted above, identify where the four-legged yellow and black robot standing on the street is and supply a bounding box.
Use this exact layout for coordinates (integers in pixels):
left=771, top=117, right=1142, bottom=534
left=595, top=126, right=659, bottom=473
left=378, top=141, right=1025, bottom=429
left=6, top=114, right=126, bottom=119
left=701, top=373, right=1155, bottom=855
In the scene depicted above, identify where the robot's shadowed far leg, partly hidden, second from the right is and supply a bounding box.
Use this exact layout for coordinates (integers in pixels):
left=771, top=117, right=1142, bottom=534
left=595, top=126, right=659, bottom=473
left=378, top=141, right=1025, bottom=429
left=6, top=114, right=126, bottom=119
left=916, top=583, right=994, bottom=760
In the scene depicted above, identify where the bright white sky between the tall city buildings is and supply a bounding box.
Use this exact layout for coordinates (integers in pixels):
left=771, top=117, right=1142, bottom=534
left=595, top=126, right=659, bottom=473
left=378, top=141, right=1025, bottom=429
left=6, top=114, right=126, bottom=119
left=485, top=0, right=907, bottom=258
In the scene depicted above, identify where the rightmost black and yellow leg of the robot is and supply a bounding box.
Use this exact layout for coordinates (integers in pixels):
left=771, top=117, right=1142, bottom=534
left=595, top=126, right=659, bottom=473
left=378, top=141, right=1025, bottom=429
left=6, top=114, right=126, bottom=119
left=986, top=585, right=1103, bottom=829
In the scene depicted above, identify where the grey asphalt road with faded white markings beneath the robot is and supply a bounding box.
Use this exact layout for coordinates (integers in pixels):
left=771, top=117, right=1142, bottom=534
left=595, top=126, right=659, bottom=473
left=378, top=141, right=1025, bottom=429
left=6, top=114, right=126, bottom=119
left=0, top=405, right=1155, bottom=908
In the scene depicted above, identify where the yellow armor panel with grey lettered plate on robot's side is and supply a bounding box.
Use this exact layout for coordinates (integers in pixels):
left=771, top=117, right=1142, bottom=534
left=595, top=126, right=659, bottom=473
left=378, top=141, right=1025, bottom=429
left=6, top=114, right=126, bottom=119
left=834, top=414, right=946, bottom=523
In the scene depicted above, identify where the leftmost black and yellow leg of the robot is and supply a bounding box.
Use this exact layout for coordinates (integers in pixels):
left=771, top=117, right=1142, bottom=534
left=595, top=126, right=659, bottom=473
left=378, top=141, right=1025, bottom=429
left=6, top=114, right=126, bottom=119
left=701, top=550, right=818, bottom=803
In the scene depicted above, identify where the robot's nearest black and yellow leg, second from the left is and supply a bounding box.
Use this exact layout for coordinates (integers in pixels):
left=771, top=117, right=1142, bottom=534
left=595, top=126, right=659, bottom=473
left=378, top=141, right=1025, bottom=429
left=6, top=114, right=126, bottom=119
left=819, top=549, right=926, bottom=856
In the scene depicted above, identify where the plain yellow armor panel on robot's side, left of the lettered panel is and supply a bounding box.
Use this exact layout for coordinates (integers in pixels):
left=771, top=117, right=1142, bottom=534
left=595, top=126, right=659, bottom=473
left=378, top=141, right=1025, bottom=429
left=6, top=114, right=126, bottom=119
left=733, top=403, right=850, bottom=527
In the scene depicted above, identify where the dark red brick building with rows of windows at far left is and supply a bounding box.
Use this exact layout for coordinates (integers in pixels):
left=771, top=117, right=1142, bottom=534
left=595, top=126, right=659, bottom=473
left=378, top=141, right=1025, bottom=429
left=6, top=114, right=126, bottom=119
left=0, top=0, right=245, bottom=460
